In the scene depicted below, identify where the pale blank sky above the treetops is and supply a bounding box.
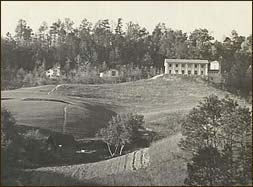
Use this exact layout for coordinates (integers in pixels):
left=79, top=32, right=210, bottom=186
left=1, top=1, right=252, bottom=40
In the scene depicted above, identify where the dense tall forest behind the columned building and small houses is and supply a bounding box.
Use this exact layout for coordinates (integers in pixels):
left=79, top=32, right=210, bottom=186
left=1, top=18, right=252, bottom=96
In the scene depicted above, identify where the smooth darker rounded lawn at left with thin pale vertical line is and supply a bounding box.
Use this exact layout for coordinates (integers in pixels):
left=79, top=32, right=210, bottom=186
left=1, top=85, right=115, bottom=138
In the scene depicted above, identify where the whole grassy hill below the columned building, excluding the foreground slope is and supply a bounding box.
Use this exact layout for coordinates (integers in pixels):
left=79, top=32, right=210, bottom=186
left=1, top=77, right=249, bottom=138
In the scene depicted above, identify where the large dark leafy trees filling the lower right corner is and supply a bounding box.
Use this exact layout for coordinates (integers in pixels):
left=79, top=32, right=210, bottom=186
left=180, top=95, right=252, bottom=185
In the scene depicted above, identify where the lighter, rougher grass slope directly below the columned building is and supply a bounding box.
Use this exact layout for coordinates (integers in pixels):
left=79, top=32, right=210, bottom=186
left=50, top=77, right=249, bottom=137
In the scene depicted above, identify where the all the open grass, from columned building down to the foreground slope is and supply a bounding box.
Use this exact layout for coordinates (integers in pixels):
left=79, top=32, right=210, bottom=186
left=2, top=77, right=250, bottom=185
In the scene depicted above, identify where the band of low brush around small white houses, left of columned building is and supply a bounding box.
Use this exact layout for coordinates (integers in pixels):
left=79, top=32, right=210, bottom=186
left=1, top=65, right=163, bottom=90
